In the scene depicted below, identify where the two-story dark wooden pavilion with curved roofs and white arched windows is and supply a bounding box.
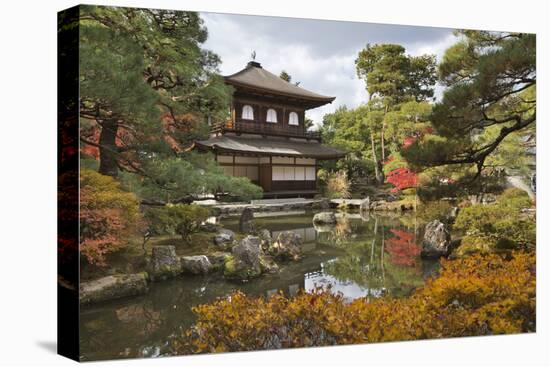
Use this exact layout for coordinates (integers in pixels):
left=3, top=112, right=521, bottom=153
left=195, top=61, right=345, bottom=197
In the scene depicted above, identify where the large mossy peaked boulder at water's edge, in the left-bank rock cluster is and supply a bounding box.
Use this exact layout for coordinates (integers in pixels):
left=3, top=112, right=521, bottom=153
left=224, top=236, right=262, bottom=280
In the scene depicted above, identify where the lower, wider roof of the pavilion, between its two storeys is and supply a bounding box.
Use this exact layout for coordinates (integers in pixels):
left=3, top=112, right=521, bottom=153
left=195, top=135, right=345, bottom=159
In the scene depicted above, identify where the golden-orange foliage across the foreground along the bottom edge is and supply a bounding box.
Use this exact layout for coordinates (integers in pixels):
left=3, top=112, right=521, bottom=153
left=173, top=252, right=536, bottom=353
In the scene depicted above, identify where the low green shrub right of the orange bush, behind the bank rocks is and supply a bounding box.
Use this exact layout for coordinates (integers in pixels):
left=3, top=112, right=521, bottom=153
left=145, top=204, right=210, bottom=241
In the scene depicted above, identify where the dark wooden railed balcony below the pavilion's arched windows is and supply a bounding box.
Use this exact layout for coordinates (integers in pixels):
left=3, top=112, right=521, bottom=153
left=211, top=120, right=321, bottom=141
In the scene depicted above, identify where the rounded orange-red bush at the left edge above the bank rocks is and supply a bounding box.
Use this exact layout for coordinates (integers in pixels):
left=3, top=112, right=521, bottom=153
left=79, top=170, right=139, bottom=266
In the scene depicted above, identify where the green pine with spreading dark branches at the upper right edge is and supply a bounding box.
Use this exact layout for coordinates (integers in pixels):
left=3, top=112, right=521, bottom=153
left=404, top=31, right=536, bottom=178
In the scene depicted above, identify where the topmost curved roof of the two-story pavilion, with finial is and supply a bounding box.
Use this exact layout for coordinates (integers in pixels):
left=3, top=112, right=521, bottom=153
left=224, top=61, right=336, bottom=107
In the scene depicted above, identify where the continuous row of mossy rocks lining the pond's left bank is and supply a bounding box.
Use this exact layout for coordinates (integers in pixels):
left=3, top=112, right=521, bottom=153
left=79, top=229, right=302, bottom=305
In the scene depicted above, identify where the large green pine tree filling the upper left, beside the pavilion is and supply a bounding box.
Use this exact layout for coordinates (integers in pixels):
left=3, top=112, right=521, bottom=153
left=80, top=6, right=229, bottom=176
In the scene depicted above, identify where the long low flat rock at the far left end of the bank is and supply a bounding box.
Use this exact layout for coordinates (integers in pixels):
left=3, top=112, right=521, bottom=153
left=80, top=272, right=148, bottom=305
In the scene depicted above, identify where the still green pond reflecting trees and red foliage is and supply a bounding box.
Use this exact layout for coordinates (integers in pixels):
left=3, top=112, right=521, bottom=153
left=80, top=212, right=438, bottom=360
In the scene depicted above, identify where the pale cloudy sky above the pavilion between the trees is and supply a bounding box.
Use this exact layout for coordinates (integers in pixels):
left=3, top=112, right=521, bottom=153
left=201, top=13, right=456, bottom=128
